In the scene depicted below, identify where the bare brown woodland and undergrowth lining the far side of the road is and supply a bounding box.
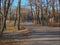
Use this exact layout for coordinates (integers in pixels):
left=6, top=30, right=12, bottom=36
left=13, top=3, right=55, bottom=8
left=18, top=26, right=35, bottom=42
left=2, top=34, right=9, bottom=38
left=0, top=0, right=60, bottom=37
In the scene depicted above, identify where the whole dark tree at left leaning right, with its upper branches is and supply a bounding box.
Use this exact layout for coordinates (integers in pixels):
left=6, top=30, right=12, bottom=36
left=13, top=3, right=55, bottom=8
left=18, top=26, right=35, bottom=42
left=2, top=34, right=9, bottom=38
left=1, top=0, right=12, bottom=37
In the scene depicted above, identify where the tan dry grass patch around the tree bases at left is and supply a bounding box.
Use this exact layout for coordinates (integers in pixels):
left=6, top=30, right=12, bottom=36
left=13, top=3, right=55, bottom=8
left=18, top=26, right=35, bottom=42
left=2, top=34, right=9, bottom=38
left=4, top=21, right=29, bottom=35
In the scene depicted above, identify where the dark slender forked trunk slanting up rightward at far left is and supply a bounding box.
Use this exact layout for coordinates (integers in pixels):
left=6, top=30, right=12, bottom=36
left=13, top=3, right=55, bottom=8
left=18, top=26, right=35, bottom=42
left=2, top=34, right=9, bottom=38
left=1, top=0, right=10, bottom=37
